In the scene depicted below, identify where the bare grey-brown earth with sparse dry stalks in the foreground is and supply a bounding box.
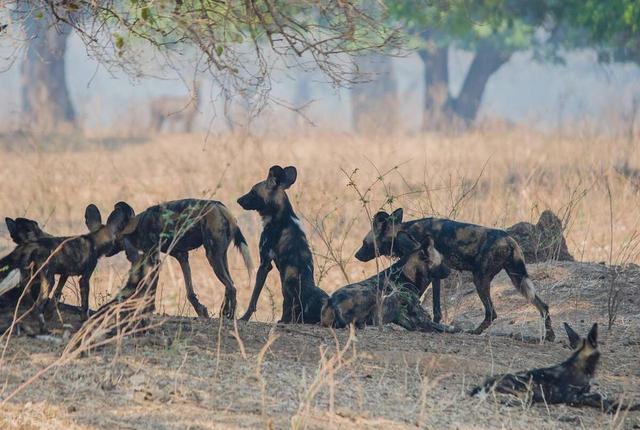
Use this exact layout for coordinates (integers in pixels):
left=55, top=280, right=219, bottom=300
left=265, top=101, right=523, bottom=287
left=0, top=262, right=640, bottom=429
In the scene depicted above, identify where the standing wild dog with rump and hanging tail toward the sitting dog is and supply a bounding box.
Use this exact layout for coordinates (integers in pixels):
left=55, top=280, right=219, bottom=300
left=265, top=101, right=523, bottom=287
left=109, top=199, right=253, bottom=318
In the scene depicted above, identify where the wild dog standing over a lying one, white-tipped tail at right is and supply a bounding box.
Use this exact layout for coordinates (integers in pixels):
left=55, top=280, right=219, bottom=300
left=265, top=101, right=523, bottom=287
left=355, top=209, right=555, bottom=341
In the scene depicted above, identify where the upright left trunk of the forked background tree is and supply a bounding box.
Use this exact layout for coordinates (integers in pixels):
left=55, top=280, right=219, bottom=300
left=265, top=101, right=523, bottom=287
left=418, top=39, right=451, bottom=131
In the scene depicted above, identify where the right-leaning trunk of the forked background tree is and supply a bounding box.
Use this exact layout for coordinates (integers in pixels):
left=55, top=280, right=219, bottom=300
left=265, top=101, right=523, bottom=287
left=451, top=42, right=512, bottom=123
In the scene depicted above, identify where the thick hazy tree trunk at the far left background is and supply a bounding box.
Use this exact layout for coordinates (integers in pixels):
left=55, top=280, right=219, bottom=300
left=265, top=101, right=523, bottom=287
left=20, top=8, right=76, bottom=132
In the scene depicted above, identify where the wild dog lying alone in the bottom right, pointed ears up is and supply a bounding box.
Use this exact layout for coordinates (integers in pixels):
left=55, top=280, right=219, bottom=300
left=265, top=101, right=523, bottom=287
left=470, top=323, right=640, bottom=413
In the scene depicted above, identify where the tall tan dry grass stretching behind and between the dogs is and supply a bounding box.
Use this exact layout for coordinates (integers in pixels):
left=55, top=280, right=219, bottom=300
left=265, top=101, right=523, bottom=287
left=0, top=127, right=640, bottom=321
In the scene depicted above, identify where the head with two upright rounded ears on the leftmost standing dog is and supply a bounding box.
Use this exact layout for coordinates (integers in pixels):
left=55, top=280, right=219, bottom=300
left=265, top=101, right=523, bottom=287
left=84, top=202, right=134, bottom=256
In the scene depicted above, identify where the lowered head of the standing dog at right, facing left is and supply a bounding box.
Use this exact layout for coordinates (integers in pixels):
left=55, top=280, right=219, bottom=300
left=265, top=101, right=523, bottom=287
left=355, top=208, right=403, bottom=261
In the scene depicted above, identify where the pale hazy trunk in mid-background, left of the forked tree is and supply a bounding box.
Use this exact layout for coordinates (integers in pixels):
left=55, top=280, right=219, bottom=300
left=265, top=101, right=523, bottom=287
left=351, top=54, right=399, bottom=133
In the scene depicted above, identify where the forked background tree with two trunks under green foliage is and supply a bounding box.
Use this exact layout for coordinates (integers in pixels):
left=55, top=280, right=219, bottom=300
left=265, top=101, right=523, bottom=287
left=388, top=0, right=547, bottom=130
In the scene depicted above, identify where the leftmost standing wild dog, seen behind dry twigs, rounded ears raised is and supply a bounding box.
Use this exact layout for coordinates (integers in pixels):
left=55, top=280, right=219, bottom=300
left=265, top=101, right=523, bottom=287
left=0, top=204, right=129, bottom=331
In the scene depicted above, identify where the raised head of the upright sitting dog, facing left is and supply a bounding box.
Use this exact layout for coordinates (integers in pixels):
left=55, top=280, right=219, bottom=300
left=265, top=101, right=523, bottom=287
left=238, top=166, right=298, bottom=216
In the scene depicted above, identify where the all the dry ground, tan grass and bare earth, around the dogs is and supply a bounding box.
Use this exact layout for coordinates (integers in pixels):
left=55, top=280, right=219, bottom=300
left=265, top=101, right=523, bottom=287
left=0, top=130, right=640, bottom=428
